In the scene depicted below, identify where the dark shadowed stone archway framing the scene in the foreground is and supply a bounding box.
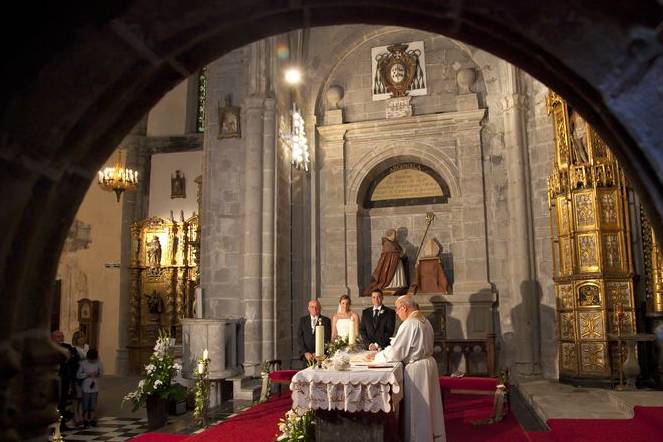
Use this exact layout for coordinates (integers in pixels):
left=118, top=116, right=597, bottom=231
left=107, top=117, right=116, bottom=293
left=0, top=0, right=663, bottom=440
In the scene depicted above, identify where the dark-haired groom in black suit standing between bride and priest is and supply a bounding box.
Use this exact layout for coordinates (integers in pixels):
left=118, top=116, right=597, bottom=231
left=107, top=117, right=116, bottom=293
left=359, top=289, right=396, bottom=350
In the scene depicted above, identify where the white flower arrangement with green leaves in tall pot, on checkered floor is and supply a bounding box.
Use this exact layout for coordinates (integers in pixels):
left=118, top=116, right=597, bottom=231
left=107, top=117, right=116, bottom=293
left=123, top=330, right=183, bottom=430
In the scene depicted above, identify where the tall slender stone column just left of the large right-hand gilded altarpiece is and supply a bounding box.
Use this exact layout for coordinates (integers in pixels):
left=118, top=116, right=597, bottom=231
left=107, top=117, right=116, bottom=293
left=503, top=65, right=539, bottom=375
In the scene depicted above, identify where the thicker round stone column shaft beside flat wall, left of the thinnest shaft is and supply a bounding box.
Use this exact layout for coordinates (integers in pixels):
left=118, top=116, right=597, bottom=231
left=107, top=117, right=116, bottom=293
left=240, top=95, right=265, bottom=375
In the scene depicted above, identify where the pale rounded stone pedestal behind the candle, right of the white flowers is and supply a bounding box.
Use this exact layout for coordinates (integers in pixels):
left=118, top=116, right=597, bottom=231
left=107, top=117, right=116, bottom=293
left=182, top=318, right=244, bottom=380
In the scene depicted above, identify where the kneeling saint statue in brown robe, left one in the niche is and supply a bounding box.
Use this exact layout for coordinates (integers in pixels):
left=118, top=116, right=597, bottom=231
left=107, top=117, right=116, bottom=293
left=364, top=229, right=408, bottom=296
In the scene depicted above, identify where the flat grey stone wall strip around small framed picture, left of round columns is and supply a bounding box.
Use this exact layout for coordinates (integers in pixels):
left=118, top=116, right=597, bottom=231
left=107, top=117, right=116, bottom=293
left=200, top=48, right=249, bottom=318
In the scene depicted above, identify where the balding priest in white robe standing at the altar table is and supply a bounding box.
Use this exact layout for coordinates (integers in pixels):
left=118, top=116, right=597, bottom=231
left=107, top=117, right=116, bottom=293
left=368, top=295, right=446, bottom=442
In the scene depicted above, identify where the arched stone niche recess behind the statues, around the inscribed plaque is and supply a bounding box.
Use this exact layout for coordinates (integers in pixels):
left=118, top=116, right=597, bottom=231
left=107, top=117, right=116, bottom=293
left=356, top=154, right=460, bottom=294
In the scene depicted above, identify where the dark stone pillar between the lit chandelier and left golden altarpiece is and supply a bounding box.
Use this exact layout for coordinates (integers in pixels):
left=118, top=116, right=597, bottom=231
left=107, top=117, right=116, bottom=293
left=115, top=117, right=151, bottom=376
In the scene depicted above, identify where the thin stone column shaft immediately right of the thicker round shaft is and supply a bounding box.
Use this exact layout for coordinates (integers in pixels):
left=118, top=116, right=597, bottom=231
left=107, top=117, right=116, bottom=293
left=261, top=98, right=276, bottom=360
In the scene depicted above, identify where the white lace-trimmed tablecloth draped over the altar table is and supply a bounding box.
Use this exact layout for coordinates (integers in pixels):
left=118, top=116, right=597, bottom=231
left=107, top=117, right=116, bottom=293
left=290, top=363, right=403, bottom=413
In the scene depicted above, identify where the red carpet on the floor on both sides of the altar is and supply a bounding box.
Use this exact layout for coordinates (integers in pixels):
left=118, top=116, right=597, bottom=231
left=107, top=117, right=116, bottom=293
left=132, top=377, right=663, bottom=442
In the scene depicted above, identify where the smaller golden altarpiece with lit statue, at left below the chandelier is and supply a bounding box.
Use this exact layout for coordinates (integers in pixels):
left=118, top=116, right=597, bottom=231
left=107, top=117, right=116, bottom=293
left=127, top=214, right=200, bottom=373
